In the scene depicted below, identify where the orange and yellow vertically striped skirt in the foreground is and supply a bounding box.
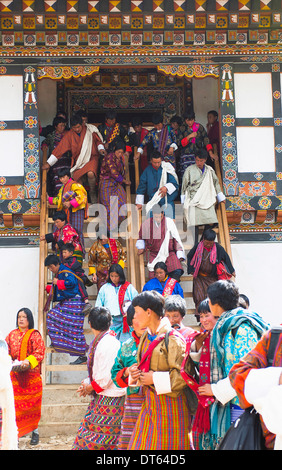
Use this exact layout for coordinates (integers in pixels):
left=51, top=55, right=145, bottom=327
left=128, top=388, right=192, bottom=450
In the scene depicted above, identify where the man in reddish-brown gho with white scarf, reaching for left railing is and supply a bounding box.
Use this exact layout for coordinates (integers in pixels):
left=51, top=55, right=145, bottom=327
left=42, top=115, right=105, bottom=202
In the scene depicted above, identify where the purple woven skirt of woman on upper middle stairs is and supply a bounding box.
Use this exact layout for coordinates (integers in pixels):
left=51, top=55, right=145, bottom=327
left=99, top=179, right=126, bottom=231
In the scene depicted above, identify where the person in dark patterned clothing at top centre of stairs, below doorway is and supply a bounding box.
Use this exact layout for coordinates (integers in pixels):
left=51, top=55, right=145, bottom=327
left=98, top=111, right=131, bottom=153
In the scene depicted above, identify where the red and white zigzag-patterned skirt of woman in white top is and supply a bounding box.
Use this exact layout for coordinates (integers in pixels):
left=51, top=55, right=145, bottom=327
left=72, top=395, right=124, bottom=450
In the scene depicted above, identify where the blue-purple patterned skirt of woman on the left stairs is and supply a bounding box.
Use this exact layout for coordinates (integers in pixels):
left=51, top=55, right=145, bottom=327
left=46, top=298, right=87, bottom=356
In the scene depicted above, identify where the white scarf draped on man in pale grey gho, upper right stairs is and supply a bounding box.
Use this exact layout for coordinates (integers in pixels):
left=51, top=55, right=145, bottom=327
left=184, top=165, right=216, bottom=222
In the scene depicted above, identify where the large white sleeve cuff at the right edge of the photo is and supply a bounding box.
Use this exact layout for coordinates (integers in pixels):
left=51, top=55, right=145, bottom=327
left=244, top=367, right=282, bottom=404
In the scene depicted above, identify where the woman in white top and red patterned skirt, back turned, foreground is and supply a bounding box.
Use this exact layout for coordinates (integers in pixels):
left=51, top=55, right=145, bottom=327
left=72, top=307, right=126, bottom=450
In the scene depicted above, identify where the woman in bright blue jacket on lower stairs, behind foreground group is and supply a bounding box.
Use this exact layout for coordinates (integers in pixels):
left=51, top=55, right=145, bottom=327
left=143, top=261, right=184, bottom=297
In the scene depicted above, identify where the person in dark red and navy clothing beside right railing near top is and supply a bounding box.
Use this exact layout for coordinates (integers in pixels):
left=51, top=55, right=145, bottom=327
left=179, top=112, right=216, bottom=178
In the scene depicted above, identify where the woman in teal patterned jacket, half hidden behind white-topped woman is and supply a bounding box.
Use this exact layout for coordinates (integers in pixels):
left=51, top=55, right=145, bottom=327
left=112, top=304, right=145, bottom=450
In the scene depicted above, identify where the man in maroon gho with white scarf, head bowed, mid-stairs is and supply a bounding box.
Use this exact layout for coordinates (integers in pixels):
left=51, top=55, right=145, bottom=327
left=136, top=206, right=185, bottom=281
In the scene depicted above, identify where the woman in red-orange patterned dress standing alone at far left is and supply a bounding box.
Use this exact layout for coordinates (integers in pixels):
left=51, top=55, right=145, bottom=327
left=6, top=308, right=45, bottom=445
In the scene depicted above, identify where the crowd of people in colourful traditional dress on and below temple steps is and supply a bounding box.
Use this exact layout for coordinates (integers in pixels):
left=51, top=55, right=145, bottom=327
left=0, top=107, right=282, bottom=450
